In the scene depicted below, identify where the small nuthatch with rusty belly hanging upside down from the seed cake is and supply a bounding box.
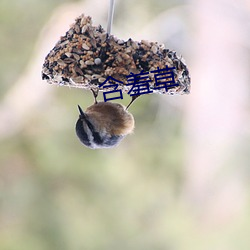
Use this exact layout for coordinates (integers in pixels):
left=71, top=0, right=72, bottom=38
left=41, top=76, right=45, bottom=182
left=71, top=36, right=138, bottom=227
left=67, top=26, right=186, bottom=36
left=76, top=91, right=135, bottom=149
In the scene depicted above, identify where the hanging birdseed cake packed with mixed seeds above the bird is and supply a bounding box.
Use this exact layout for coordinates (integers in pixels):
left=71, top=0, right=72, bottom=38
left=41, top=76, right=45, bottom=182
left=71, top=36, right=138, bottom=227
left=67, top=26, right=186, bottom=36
left=42, top=15, right=190, bottom=94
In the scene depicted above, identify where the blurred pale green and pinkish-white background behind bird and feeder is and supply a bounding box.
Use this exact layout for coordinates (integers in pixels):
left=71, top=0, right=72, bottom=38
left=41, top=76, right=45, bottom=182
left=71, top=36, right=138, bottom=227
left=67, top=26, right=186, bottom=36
left=0, top=0, right=250, bottom=250
